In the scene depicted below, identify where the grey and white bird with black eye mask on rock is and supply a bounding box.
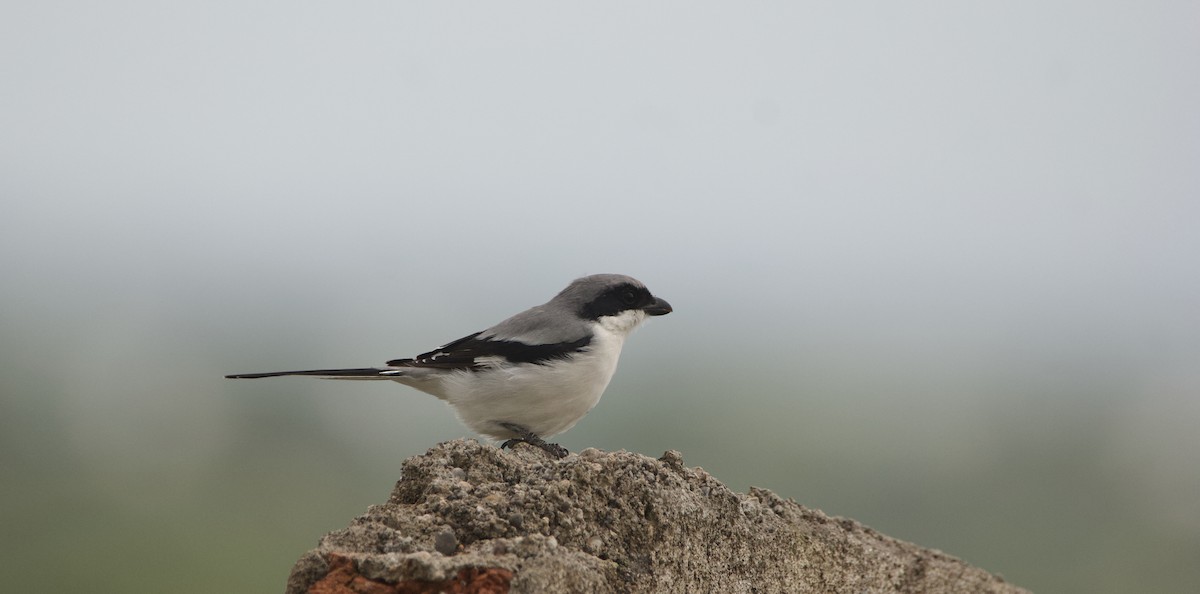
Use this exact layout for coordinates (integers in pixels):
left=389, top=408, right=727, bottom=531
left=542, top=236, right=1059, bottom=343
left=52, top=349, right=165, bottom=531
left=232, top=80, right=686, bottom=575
left=226, top=274, right=673, bottom=458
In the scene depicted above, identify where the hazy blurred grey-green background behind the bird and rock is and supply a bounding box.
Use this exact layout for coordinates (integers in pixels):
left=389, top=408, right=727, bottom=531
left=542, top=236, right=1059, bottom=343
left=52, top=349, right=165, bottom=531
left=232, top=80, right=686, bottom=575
left=0, top=1, right=1200, bottom=593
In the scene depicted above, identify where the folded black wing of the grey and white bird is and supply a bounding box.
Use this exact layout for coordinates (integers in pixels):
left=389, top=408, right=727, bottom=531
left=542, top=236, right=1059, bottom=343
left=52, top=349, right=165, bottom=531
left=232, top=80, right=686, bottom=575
left=388, top=332, right=592, bottom=370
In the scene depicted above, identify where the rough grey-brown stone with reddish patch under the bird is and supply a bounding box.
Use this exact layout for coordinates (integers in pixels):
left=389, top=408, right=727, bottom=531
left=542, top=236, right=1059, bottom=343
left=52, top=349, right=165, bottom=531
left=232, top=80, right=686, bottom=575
left=288, top=439, right=1025, bottom=594
